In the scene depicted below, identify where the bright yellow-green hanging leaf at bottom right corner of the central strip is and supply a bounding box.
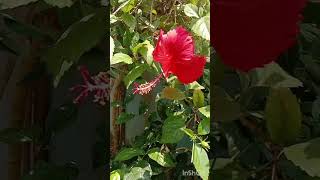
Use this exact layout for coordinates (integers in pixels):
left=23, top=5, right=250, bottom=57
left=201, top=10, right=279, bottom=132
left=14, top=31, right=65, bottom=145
left=191, top=143, right=210, bottom=180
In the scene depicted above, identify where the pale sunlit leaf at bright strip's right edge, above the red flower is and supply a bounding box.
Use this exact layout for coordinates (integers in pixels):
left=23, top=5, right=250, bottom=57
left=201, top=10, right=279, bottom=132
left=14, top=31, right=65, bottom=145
left=192, top=15, right=210, bottom=41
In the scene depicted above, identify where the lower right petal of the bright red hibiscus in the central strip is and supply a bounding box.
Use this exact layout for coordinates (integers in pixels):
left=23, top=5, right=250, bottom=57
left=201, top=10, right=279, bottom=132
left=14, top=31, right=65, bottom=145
left=172, top=56, right=206, bottom=84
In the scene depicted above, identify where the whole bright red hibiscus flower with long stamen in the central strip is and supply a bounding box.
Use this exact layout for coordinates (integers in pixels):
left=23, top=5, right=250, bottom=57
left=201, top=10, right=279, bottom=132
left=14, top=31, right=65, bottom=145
left=133, top=27, right=206, bottom=95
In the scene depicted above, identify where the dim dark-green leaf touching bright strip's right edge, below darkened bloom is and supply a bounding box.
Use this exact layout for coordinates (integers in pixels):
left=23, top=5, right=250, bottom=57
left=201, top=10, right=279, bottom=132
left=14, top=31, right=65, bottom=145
left=212, top=86, right=241, bottom=122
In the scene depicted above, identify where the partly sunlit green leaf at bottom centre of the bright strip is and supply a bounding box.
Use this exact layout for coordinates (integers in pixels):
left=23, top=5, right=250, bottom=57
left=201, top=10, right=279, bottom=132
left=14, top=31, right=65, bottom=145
left=148, top=148, right=175, bottom=167
